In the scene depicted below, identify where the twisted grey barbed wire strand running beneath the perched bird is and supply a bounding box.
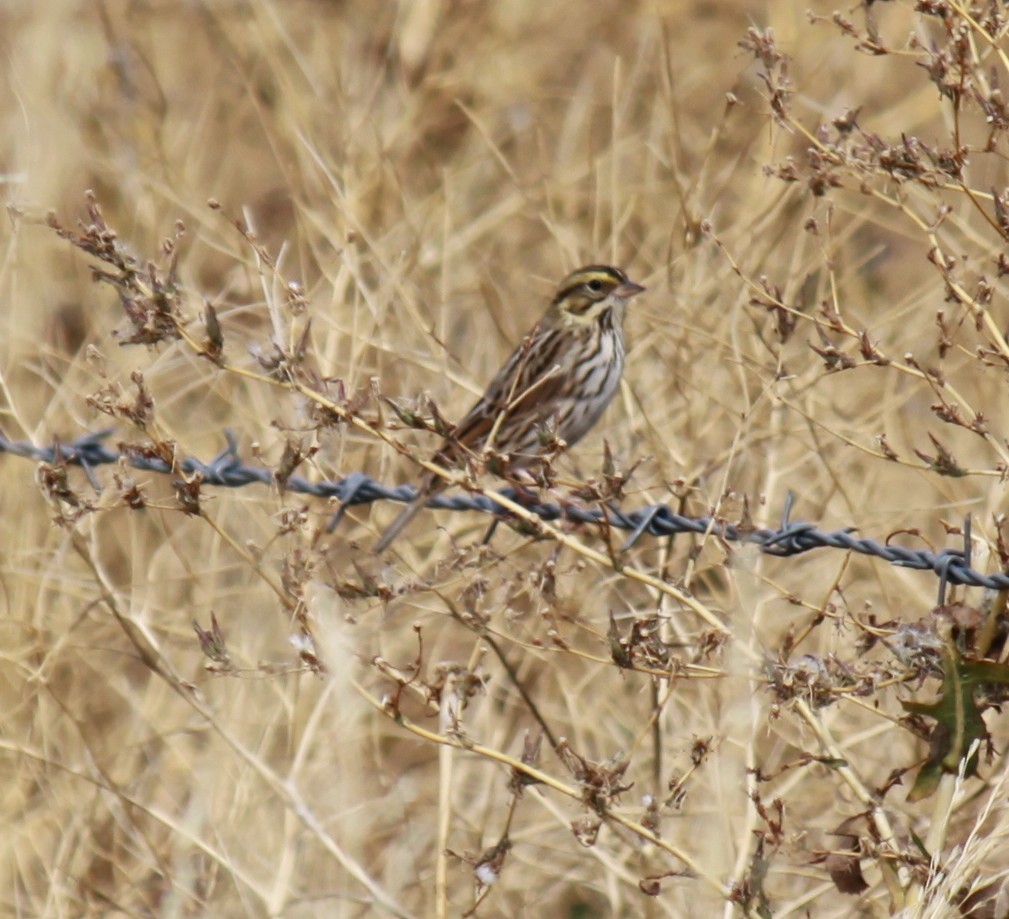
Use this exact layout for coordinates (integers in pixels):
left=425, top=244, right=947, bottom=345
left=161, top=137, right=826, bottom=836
left=0, top=430, right=1009, bottom=604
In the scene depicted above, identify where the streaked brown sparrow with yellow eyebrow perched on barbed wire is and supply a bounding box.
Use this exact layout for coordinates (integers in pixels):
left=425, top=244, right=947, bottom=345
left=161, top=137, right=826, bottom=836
left=375, top=264, right=645, bottom=553
